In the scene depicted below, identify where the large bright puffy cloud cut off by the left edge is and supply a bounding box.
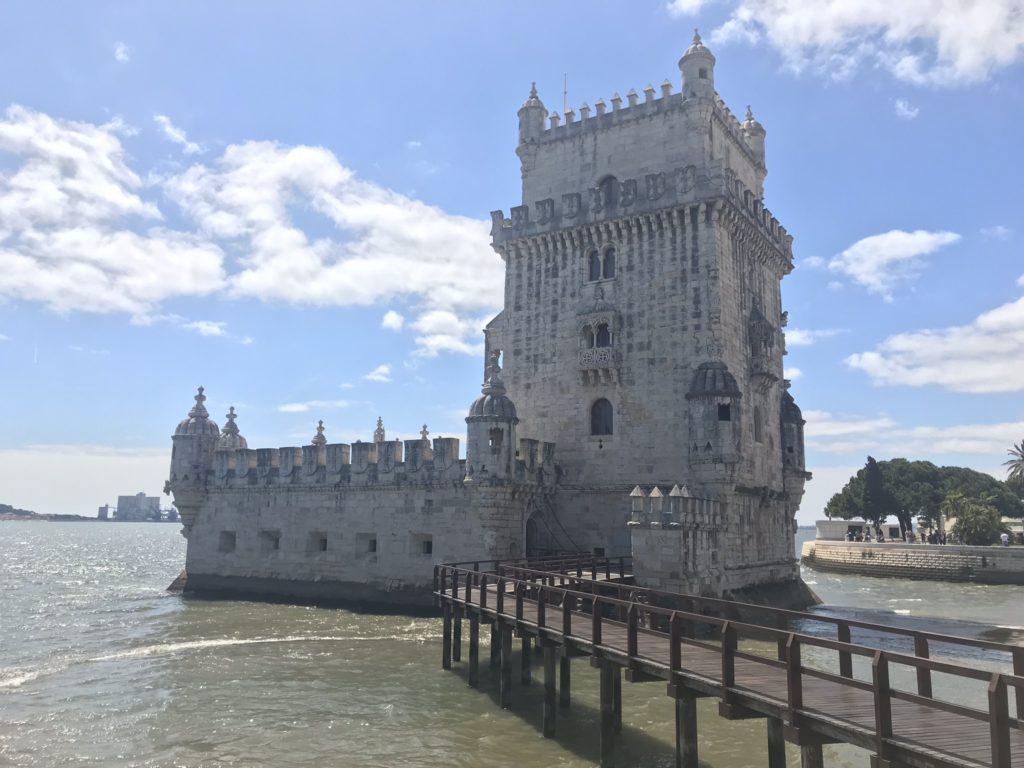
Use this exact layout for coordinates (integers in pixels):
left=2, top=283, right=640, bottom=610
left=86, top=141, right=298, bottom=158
left=0, top=105, right=224, bottom=315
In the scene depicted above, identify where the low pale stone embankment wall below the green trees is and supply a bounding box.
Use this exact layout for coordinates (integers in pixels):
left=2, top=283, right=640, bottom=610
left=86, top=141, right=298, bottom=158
left=801, top=540, right=1024, bottom=584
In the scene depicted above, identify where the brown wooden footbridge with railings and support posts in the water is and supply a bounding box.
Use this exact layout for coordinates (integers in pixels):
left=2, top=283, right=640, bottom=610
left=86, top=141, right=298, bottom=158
left=434, top=557, right=1024, bottom=768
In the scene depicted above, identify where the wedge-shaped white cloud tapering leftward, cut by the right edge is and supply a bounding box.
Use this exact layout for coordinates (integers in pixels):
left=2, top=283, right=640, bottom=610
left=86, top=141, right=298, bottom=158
left=846, top=298, right=1024, bottom=393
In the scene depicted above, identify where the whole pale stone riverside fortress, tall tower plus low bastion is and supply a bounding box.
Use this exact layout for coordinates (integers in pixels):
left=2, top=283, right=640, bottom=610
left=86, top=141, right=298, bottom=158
left=167, top=34, right=810, bottom=606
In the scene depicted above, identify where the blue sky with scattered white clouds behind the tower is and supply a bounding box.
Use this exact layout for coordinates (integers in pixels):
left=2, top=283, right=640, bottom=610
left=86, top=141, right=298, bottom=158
left=0, top=0, right=1024, bottom=523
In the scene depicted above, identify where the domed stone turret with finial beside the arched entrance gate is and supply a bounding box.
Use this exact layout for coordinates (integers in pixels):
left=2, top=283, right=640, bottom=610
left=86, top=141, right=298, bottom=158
left=466, top=355, right=519, bottom=482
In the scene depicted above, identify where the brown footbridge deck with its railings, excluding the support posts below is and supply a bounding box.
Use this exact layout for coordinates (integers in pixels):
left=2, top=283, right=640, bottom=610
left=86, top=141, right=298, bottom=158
left=435, top=558, right=1024, bottom=768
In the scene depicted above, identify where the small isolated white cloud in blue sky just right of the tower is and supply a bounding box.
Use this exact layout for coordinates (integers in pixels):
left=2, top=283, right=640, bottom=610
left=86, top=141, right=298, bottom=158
left=828, top=229, right=961, bottom=300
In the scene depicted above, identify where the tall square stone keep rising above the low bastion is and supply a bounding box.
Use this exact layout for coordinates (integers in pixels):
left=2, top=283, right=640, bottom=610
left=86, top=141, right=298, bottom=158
left=485, top=34, right=808, bottom=563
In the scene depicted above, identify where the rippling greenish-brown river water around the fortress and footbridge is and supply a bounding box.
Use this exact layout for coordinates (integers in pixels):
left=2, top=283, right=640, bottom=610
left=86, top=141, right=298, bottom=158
left=0, top=522, right=1024, bottom=768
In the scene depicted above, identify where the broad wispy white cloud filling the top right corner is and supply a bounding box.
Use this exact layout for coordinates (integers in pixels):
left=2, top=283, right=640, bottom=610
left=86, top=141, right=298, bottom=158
left=708, top=0, right=1024, bottom=85
